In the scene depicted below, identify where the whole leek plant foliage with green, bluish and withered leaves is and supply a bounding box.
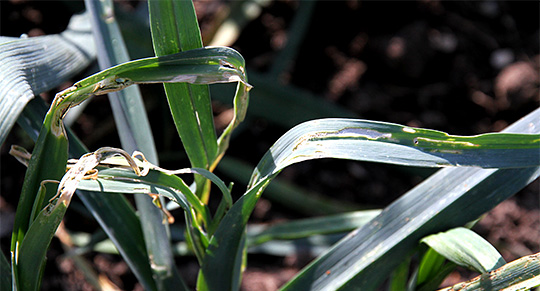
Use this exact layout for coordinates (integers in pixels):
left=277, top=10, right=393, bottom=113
left=0, top=0, right=540, bottom=290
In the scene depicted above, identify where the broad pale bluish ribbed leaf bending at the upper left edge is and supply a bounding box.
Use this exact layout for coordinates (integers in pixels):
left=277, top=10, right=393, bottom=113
left=0, top=13, right=96, bottom=144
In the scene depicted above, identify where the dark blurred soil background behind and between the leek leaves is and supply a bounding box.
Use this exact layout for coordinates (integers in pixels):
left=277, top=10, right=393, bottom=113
left=0, top=0, right=540, bottom=290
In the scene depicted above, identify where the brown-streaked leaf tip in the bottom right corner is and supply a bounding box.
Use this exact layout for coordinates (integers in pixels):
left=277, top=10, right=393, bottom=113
left=440, top=253, right=540, bottom=291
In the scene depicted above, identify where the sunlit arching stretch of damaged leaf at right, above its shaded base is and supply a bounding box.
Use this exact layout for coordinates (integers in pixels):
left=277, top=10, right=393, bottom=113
left=250, top=118, right=540, bottom=184
